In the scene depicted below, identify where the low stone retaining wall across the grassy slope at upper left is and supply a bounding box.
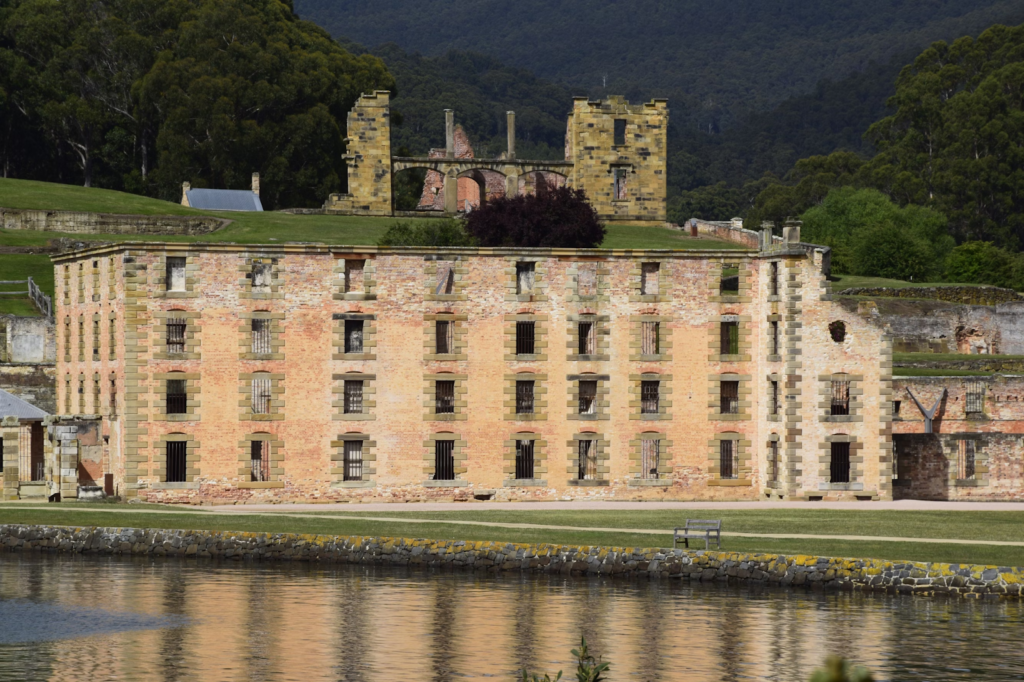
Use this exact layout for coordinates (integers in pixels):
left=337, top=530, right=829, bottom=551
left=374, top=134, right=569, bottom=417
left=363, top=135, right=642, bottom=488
left=0, top=208, right=230, bottom=235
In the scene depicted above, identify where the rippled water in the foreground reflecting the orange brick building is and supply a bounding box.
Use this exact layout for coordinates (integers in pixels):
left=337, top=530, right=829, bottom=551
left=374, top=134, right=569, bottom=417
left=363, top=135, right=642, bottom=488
left=0, top=554, right=1024, bottom=682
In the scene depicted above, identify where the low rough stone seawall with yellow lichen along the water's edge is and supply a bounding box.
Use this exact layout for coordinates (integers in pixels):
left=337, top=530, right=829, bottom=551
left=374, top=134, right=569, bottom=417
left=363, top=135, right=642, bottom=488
left=0, top=525, right=1024, bottom=598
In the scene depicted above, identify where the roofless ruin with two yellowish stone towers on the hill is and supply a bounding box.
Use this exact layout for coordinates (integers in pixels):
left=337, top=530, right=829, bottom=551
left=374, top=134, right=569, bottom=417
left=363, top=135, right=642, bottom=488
left=324, top=91, right=669, bottom=223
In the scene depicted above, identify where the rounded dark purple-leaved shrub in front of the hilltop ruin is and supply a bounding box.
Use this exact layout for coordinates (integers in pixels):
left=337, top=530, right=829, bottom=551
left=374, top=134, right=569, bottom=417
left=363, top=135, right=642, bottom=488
left=466, top=187, right=604, bottom=249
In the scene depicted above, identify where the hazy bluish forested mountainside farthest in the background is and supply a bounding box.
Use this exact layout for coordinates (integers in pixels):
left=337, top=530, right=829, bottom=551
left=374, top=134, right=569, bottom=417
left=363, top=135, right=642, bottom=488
left=295, top=0, right=1024, bottom=131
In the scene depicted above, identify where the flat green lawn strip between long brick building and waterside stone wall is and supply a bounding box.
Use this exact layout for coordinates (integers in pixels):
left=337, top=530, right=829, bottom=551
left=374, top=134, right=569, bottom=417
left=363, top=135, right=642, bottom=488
left=0, top=503, right=1024, bottom=566
